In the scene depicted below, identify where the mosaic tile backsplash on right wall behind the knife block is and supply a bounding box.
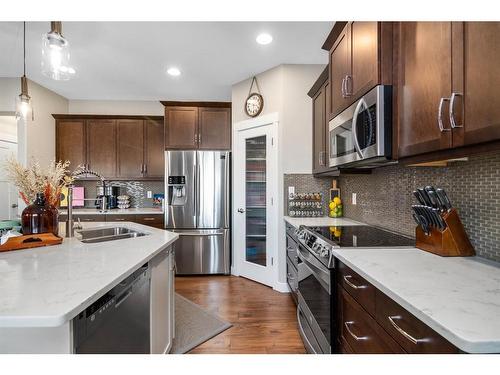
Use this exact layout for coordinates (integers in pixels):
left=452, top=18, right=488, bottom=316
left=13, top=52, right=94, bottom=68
left=339, top=151, right=500, bottom=262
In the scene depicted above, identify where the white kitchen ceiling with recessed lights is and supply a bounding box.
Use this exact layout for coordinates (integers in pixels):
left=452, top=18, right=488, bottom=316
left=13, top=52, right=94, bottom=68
left=0, top=22, right=333, bottom=100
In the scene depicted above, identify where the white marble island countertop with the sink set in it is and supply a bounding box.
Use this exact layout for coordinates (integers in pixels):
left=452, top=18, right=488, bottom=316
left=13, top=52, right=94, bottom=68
left=0, top=222, right=178, bottom=327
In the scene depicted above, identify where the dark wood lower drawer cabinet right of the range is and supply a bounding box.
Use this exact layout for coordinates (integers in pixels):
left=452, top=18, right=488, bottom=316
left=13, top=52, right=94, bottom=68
left=335, top=262, right=460, bottom=354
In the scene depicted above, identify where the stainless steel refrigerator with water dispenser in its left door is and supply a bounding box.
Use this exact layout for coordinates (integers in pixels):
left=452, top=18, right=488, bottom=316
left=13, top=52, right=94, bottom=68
left=165, top=151, right=231, bottom=275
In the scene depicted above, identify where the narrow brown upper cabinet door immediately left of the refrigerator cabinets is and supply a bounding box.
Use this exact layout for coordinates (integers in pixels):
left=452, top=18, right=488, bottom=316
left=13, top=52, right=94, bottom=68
left=144, top=119, right=165, bottom=178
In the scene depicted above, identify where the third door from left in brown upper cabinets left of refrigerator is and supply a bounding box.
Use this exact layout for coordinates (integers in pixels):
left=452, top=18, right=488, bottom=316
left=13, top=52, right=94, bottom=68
left=117, top=120, right=144, bottom=177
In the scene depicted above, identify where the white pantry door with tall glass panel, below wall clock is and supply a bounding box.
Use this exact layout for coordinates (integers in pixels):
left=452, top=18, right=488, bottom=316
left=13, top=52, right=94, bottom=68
left=233, top=116, right=278, bottom=287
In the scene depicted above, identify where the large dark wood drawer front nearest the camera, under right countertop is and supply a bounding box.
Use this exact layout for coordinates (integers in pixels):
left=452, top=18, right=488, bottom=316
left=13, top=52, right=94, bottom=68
left=376, top=290, right=458, bottom=353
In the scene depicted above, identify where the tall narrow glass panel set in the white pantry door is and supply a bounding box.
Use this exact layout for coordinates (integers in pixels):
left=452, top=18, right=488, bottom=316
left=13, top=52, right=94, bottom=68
left=245, top=135, right=267, bottom=266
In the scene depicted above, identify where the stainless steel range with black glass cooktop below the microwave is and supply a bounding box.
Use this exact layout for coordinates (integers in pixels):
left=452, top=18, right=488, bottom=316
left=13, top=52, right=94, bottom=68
left=295, top=225, right=415, bottom=354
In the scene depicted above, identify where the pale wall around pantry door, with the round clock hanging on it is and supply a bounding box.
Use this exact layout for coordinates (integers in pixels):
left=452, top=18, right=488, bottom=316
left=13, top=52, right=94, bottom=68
left=231, top=64, right=325, bottom=285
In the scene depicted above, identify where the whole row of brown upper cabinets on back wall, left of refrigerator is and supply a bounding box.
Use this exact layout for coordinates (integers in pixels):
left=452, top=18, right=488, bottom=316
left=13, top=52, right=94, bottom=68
left=53, top=114, right=165, bottom=180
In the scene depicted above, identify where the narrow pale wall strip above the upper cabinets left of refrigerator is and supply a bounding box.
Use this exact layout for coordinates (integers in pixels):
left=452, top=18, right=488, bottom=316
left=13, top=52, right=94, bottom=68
left=68, top=100, right=165, bottom=116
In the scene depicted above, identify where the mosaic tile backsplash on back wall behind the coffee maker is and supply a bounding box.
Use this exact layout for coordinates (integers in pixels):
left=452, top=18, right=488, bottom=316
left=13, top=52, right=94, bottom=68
left=75, top=181, right=164, bottom=208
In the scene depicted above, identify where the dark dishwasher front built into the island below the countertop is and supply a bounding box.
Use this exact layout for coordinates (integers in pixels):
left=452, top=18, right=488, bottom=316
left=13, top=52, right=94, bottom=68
left=73, top=264, right=151, bottom=354
